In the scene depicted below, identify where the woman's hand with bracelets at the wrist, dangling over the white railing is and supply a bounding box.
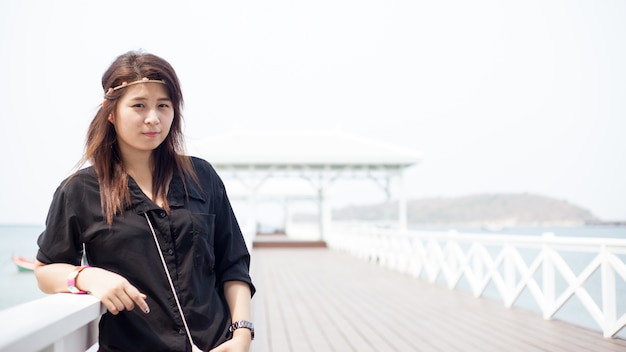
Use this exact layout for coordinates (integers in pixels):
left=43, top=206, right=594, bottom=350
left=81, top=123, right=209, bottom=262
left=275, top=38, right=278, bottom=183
left=77, top=267, right=150, bottom=315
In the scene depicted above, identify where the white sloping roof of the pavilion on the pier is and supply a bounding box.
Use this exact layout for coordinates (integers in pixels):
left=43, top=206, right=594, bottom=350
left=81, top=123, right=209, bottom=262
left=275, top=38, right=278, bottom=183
left=187, top=130, right=422, bottom=169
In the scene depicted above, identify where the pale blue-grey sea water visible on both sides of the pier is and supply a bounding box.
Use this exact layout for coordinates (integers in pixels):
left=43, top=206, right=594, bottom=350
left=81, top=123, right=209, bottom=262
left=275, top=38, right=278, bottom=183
left=0, top=225, right=626, bottom=338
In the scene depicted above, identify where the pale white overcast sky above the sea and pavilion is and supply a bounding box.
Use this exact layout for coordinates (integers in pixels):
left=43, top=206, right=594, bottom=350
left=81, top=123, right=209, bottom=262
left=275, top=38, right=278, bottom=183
left=0, top=0, right=626, bottom=224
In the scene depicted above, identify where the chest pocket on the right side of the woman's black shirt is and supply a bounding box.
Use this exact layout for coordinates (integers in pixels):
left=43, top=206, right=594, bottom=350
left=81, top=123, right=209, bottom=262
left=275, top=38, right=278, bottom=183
left=191, top=214, right=215, bottom=273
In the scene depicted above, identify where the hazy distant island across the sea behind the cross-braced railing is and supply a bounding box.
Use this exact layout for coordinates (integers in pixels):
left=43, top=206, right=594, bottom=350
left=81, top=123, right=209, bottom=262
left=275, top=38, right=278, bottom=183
left=330, top=193, right=604, bottom=228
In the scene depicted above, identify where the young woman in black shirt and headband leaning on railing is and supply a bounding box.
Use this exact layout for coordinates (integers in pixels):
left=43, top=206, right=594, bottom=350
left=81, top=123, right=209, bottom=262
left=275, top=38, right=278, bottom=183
left=35, top=52, right=255, bottom=352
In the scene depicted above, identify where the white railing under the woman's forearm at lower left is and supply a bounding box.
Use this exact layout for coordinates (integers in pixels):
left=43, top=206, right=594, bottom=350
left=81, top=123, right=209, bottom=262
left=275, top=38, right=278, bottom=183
left=0, top=293, right=104, bottom=352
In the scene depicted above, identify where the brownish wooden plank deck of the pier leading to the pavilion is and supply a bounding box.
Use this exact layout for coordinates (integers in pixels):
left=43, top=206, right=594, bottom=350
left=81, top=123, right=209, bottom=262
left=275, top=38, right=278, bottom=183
left=251, top=248, right=626, bottom=352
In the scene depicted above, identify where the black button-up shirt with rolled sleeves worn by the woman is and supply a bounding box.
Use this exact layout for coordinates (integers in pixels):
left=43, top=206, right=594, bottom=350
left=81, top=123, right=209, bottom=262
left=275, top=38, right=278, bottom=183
left=37, top=158, right=255, bottom=351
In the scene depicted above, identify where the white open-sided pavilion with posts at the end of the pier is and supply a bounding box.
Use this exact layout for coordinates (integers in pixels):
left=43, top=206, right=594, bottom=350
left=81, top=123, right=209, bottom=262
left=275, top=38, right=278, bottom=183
left=187, top=130, right=422, bottom=245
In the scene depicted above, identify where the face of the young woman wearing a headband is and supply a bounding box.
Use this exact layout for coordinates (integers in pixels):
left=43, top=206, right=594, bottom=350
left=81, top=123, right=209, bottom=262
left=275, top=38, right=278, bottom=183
left=109, top=83, right=174, bottom=157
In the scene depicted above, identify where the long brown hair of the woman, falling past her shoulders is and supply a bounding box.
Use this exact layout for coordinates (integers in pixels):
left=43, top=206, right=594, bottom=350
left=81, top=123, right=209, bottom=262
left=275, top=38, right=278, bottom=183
left=82, top=51, right=198, bottom=224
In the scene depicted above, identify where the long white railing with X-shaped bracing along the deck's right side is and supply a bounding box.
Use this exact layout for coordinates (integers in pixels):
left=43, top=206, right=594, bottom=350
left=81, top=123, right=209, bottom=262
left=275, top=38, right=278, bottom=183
left=326, top=224, right=626, bottom=337
